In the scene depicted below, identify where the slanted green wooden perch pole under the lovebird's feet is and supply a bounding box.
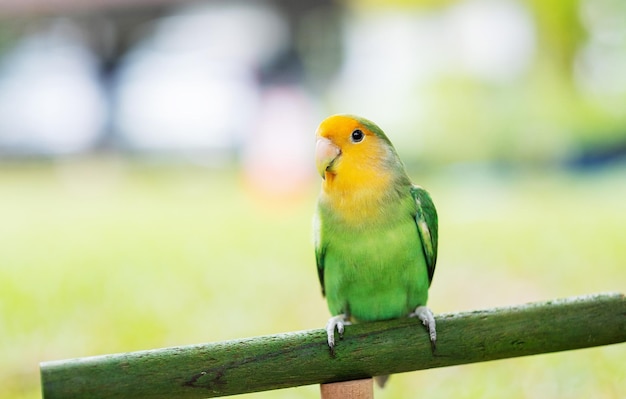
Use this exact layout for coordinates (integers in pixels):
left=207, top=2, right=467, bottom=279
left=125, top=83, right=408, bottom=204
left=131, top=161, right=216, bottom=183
left=41, top=294, right=626, bottom=399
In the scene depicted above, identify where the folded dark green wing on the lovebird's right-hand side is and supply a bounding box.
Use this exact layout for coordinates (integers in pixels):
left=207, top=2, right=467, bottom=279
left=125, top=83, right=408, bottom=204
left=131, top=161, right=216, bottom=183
left=411, top=185, right=438, bottom=283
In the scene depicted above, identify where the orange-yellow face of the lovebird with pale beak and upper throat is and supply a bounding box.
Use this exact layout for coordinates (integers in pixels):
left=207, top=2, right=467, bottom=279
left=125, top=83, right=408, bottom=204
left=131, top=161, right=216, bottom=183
left=315, top=115, right=392, bottom=195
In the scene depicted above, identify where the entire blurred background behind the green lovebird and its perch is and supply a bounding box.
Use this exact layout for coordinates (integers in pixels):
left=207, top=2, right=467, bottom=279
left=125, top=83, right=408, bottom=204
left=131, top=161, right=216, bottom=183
left=0, top=0, right=626, bottom=398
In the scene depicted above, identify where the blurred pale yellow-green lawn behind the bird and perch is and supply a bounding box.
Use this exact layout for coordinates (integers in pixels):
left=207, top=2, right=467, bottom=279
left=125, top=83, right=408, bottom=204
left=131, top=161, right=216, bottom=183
left=0, top=159, right=626, bottom=398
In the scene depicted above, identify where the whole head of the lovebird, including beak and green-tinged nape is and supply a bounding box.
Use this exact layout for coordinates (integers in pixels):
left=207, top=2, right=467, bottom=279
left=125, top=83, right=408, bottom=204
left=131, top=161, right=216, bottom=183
left=315, top=115, right=399, bottom=184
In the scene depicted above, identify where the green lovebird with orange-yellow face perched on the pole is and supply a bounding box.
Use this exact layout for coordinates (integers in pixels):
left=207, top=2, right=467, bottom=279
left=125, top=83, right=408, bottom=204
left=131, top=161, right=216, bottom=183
left=313, top=115, right=438, bottom=383
